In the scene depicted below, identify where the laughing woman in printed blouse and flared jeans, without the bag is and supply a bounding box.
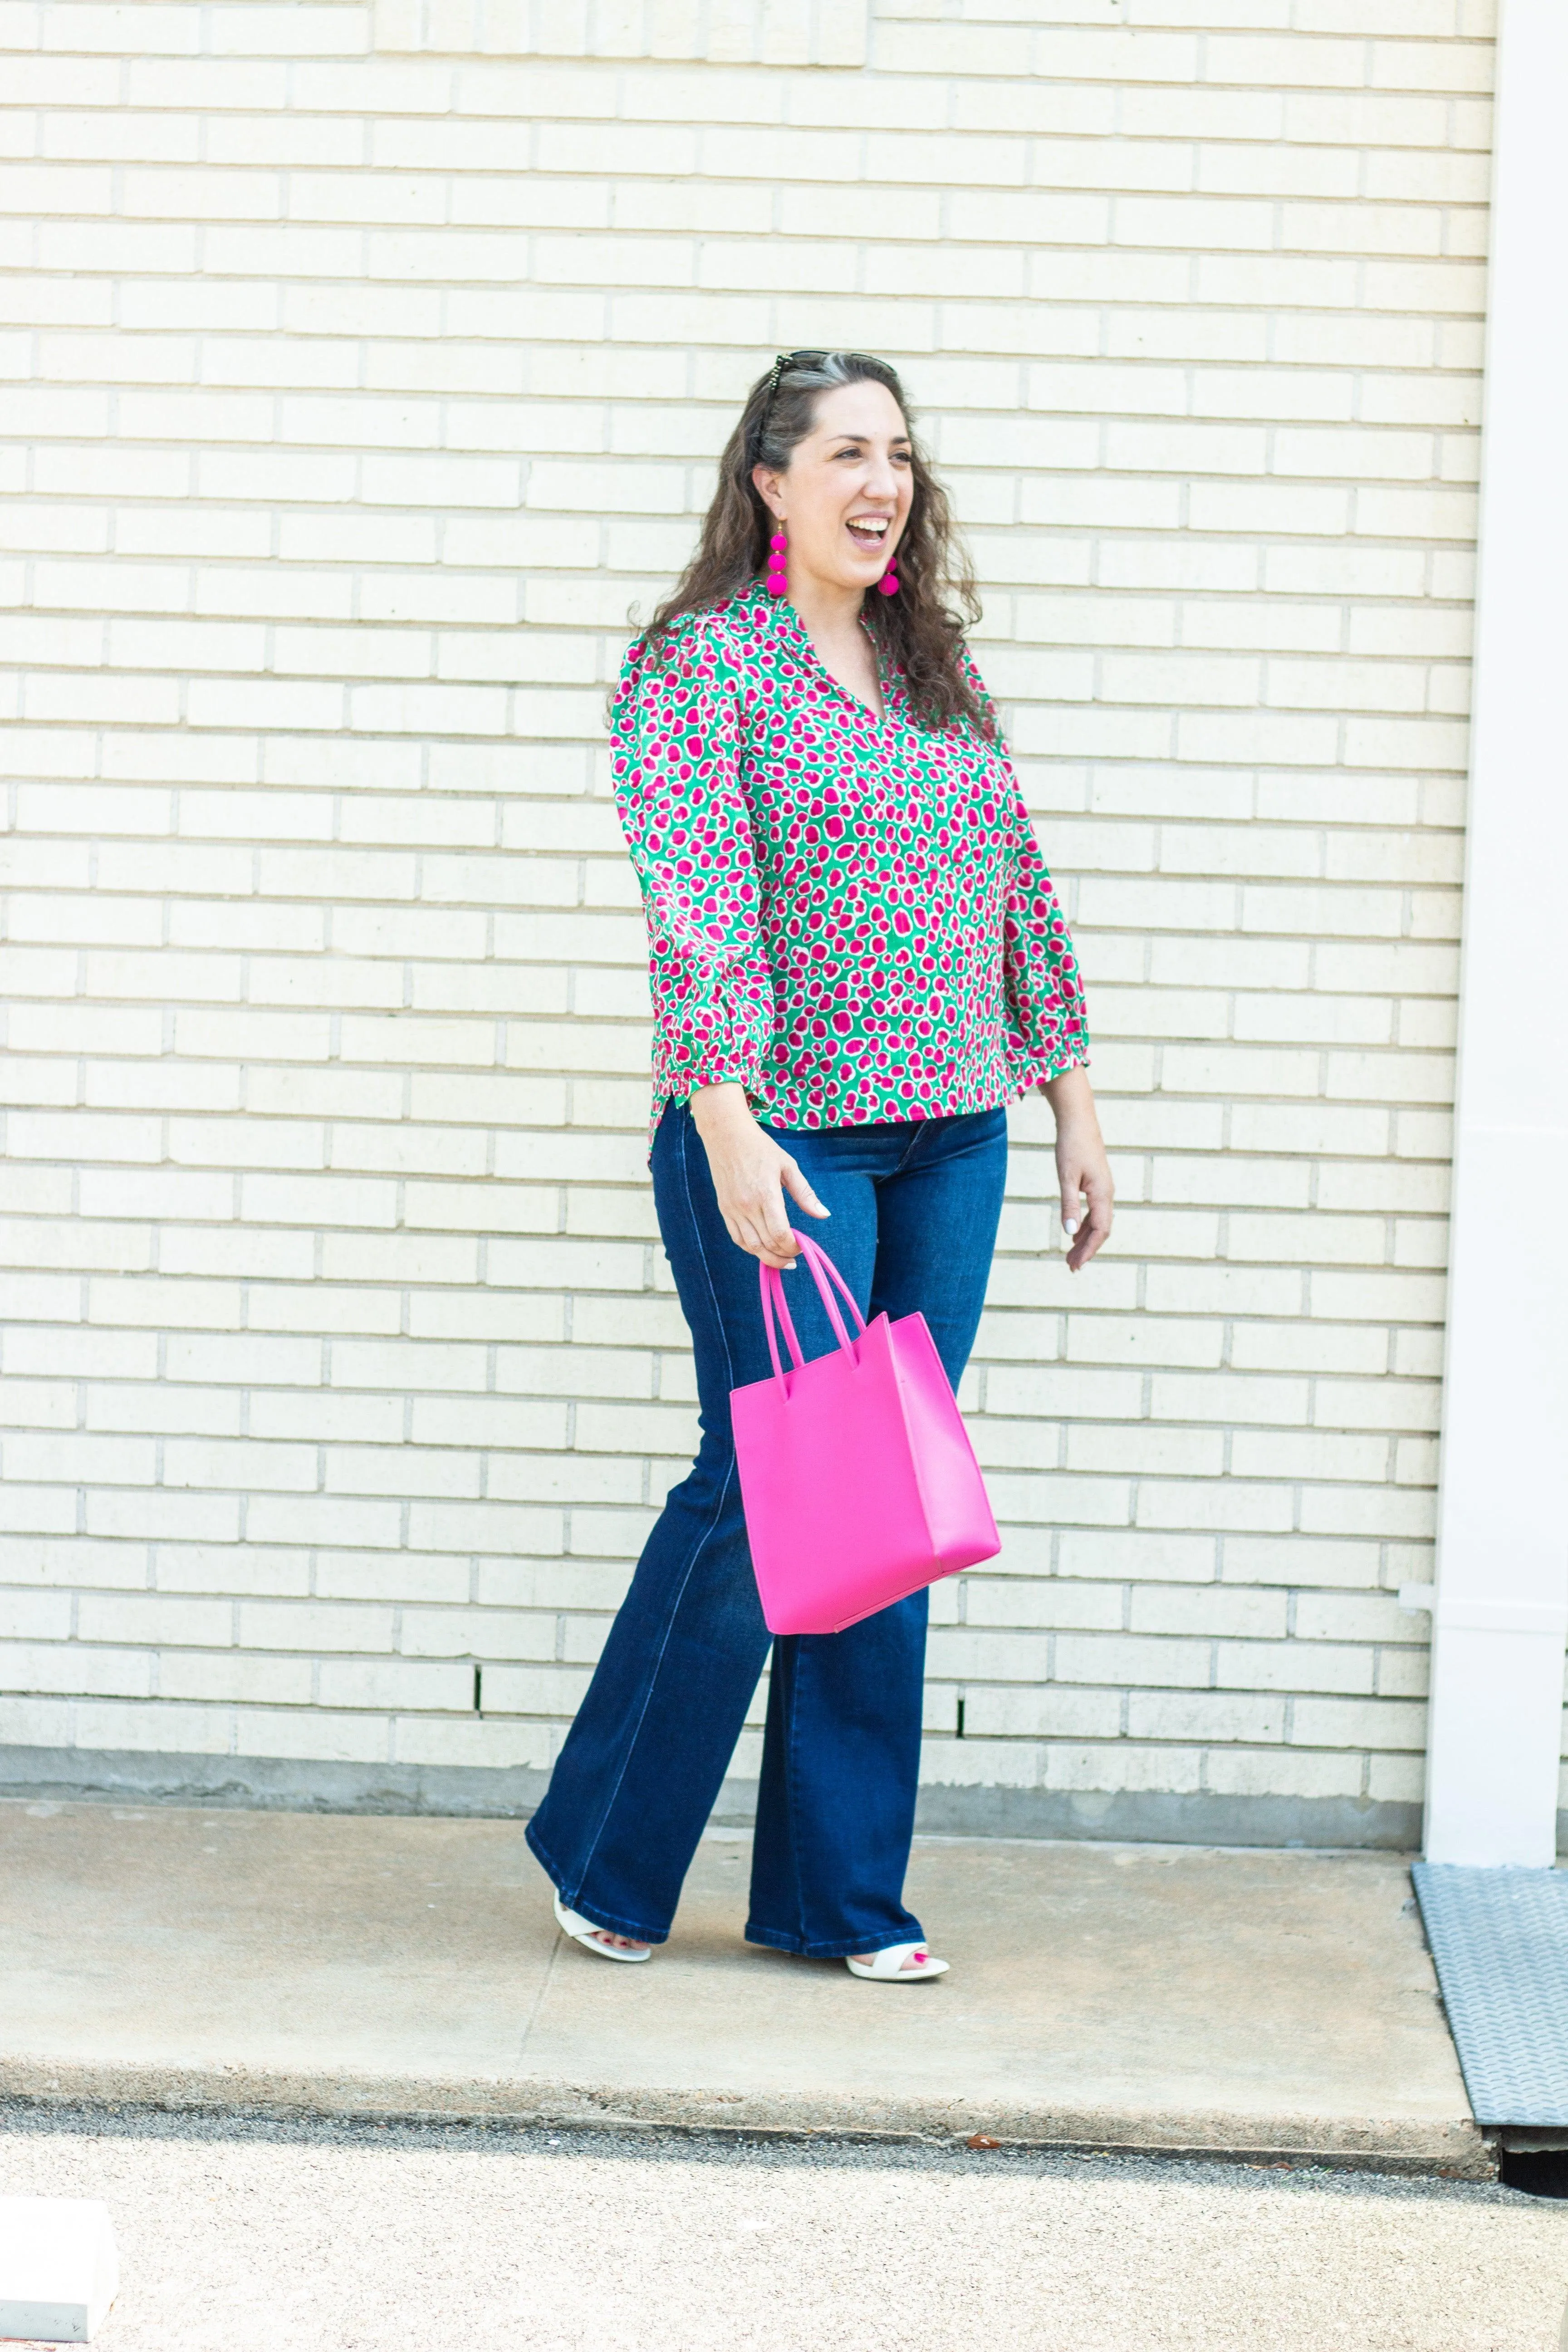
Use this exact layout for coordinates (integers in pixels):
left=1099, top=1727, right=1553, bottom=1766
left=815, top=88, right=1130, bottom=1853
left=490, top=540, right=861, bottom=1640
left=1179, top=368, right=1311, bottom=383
left=529, top=350, right=1112, bottom=1983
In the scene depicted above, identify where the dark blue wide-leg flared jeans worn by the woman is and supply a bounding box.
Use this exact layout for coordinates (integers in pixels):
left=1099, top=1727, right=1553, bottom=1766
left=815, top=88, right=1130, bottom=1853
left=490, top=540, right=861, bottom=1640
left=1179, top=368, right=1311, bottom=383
left=527, top=1103, right=1006, bottom=1959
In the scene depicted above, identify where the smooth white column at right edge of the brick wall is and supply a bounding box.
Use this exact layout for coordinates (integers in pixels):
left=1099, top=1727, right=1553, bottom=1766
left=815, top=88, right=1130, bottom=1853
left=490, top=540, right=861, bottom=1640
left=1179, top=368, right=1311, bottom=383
left=1427, top=0, right=1568, bottom=1863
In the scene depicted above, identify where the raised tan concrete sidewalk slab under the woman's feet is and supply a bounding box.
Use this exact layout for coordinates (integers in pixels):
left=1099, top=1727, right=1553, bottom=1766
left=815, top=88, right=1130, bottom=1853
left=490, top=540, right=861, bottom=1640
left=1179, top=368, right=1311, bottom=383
left=0, top=1802, right=1493, bottom=2178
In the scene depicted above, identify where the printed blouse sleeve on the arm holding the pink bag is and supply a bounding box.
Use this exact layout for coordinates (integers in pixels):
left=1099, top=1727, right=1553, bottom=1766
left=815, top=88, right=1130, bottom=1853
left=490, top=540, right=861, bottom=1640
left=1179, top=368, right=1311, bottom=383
left=611, top=628, right=774, bottom=1101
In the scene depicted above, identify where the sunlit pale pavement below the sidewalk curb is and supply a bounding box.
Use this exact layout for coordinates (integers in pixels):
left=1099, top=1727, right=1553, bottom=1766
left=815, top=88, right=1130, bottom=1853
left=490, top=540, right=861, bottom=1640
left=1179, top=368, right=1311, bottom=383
left=0, top=2105, right=1568, bottom=2352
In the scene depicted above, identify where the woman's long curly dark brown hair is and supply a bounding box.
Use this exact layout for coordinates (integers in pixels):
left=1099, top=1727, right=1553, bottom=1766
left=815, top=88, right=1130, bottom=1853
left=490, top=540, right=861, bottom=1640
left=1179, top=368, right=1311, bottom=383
left=639, top=350, right=997, bottom=739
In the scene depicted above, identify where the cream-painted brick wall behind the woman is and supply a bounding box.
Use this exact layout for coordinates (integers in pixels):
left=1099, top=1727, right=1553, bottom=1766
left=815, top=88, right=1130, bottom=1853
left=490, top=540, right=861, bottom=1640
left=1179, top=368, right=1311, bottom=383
left=0, top=0, right=1533, bottom=1835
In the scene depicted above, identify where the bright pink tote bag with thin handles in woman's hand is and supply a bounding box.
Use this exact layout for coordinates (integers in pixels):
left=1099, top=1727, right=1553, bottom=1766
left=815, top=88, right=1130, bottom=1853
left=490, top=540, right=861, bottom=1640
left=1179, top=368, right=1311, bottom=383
left=729, top=1232, right=1001, bottom=1632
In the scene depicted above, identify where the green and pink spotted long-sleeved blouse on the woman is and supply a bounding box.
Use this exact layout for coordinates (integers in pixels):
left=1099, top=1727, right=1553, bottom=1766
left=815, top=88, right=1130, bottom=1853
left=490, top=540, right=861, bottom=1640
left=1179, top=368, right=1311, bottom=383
left=611, top=583, right=1088, bottom=1129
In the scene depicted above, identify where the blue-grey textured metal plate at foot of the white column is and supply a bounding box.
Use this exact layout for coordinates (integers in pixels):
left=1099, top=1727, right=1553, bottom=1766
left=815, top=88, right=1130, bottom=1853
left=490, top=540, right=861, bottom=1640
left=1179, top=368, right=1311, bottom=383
left=1411, top=1863, right=1568, bottom=2129
